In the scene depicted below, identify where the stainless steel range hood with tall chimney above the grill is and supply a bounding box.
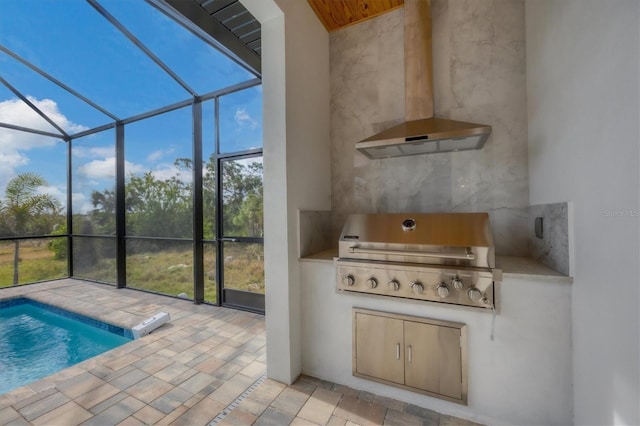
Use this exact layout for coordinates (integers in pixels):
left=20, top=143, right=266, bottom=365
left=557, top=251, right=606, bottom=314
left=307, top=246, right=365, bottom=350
left=356, top=0, right=491, bottom=159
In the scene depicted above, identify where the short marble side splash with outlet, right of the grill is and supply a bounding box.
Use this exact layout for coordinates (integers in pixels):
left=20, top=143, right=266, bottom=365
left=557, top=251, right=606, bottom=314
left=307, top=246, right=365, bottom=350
left=529, top=203, right=571, bottom=276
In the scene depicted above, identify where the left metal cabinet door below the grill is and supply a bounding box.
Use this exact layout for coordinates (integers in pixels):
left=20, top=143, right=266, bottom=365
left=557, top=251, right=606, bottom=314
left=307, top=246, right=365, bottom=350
left=354, top=313, right=404, bottom=384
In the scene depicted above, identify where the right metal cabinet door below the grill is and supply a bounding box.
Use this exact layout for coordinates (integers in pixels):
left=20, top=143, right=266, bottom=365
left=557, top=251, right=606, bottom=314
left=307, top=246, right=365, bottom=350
left=404, top=321, right=462, bottom=399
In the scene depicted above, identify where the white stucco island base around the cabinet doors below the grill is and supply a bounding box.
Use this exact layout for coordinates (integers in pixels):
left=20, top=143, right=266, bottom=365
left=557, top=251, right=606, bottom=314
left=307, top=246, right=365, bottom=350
left=301, top=261, right=572, bottom=425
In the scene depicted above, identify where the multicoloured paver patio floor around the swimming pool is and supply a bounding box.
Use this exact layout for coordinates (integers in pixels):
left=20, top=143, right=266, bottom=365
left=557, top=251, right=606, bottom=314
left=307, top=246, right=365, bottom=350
left=0, top=279, right=473, bottom=426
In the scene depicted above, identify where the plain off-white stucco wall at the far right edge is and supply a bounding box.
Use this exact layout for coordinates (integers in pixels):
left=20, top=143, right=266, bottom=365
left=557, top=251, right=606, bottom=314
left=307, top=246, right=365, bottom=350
left=526, top=0, right=640, bottom=425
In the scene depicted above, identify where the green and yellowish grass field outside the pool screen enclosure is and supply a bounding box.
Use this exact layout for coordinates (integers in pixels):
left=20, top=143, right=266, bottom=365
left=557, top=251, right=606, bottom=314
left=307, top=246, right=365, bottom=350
left=0, top=240, right=264, bottom=302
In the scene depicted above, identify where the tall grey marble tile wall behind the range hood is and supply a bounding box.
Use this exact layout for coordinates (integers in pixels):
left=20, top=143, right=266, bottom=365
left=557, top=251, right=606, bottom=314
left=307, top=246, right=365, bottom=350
left=330, top=0, right=529, bottom=256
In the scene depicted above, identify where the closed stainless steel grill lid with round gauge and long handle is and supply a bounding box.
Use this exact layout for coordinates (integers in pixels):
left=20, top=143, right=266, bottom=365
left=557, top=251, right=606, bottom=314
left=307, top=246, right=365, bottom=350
left=339, top=213, right=495, bottom=268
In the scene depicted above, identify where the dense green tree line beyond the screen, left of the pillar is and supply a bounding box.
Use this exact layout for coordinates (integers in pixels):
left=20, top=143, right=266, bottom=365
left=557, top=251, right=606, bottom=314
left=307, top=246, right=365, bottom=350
left=86, top=156, right=263, bottom=243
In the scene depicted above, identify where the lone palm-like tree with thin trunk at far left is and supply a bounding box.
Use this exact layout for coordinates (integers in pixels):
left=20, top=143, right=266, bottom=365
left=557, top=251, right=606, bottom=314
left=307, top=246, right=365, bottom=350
left=0, top=173, right=61, bottom=285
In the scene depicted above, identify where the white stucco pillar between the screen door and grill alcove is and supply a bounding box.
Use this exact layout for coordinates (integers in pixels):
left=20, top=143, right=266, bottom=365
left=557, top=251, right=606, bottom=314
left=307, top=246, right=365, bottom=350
left=243, top=0, right=331, bottom=383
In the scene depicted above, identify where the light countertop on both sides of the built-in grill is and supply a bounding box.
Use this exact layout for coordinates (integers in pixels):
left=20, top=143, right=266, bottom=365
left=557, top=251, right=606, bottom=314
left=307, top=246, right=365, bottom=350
left=300, top=248, right=573, bottom=283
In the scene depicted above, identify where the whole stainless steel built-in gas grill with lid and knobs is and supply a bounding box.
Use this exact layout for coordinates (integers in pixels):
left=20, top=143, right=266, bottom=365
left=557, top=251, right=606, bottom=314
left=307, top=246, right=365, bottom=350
left=336, top=213, right=496, bottom=310
